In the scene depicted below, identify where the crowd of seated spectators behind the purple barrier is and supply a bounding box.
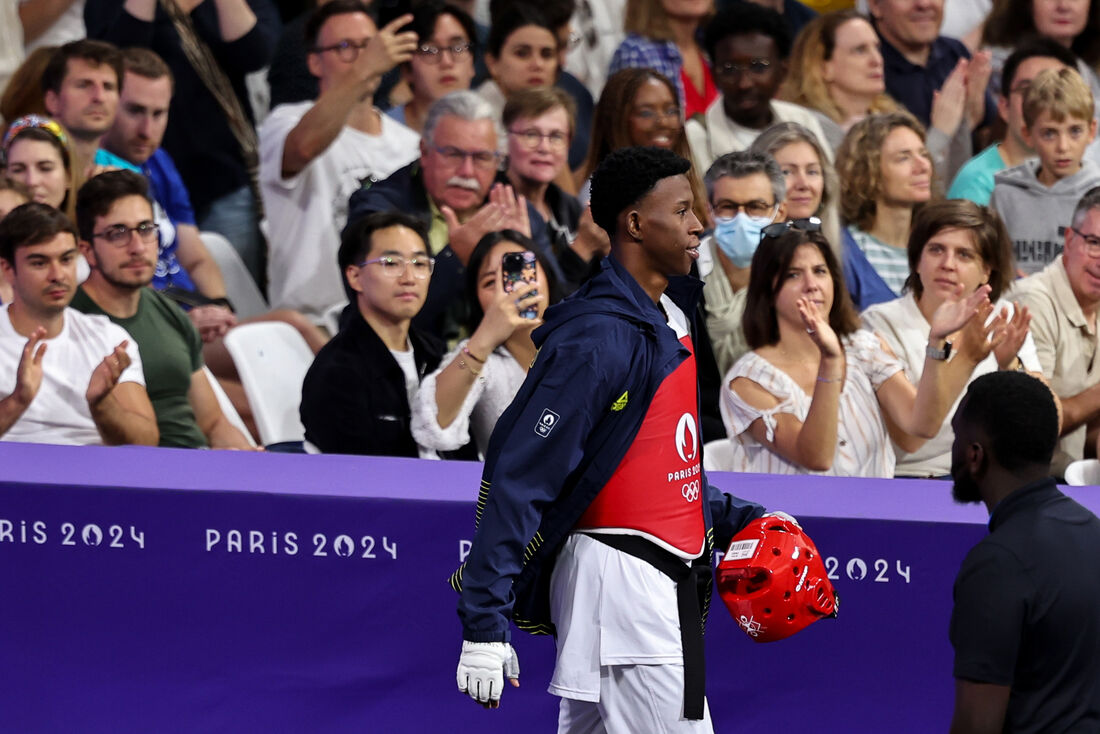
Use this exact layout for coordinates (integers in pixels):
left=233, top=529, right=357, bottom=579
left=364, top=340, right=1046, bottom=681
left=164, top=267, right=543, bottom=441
left=0, top=0, right=1100, bottom=476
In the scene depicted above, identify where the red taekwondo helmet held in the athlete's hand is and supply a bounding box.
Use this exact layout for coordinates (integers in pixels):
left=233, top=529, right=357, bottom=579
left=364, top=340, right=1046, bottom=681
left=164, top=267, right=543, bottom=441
left=717, top=517, right=840, bottom=643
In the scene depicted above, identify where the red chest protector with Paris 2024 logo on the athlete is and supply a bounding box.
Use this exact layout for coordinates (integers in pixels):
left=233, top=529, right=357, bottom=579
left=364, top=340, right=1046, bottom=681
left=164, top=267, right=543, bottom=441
left=576, top=336, right=706, bottom=558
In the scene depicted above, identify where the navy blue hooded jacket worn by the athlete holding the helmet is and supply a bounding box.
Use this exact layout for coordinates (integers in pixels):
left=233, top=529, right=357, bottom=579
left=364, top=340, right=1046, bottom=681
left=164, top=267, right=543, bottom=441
left=451, top=256, right=763, bottom=642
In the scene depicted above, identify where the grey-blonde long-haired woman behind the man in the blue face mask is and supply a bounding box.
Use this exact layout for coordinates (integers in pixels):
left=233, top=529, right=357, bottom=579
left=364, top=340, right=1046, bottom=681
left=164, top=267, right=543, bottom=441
left=749, top=122, right=840, bottom=252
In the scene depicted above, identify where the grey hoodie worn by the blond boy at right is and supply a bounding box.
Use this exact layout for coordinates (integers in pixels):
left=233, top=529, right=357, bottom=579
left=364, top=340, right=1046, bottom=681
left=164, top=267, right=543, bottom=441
left=989, top=158, right=1100, bottom=275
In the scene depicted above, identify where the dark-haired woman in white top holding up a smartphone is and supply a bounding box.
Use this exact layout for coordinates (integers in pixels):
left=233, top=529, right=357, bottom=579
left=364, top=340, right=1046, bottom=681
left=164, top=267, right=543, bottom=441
left=413, top=230, right=558, bottom=456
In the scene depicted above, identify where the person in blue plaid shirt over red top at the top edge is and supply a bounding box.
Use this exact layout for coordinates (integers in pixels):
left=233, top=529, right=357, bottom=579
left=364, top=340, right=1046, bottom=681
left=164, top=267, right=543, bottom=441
left=609, top=0, right=718, bottom=120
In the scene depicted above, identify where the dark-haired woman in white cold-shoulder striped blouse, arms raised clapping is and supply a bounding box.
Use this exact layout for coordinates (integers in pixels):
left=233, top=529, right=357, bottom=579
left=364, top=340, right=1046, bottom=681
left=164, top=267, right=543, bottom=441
left=722, top=221, right=1003, bottom=476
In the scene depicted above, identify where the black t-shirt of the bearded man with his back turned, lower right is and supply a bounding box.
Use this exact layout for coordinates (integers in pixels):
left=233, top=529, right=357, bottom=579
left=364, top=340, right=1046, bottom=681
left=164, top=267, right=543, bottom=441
left=950, top=479, right=1100, bottom=732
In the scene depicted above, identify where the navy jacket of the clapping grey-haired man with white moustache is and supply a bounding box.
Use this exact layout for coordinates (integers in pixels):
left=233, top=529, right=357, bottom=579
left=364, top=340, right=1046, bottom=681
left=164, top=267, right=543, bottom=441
left=348, top=161, right=558, bottom=339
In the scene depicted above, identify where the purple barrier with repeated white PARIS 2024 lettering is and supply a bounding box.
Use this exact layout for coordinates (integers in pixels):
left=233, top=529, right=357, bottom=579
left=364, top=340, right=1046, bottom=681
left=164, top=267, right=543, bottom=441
left=0, top=445, right=1100, bottom=734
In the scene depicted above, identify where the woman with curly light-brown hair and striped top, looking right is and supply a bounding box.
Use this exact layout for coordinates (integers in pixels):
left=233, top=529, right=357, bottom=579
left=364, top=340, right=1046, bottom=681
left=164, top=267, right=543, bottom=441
left=836, top=112, right=935, bottom=310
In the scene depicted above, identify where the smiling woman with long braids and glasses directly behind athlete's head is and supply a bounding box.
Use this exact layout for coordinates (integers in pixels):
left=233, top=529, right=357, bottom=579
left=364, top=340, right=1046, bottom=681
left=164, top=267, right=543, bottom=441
left=578, top=68, right=711, bottom=224
